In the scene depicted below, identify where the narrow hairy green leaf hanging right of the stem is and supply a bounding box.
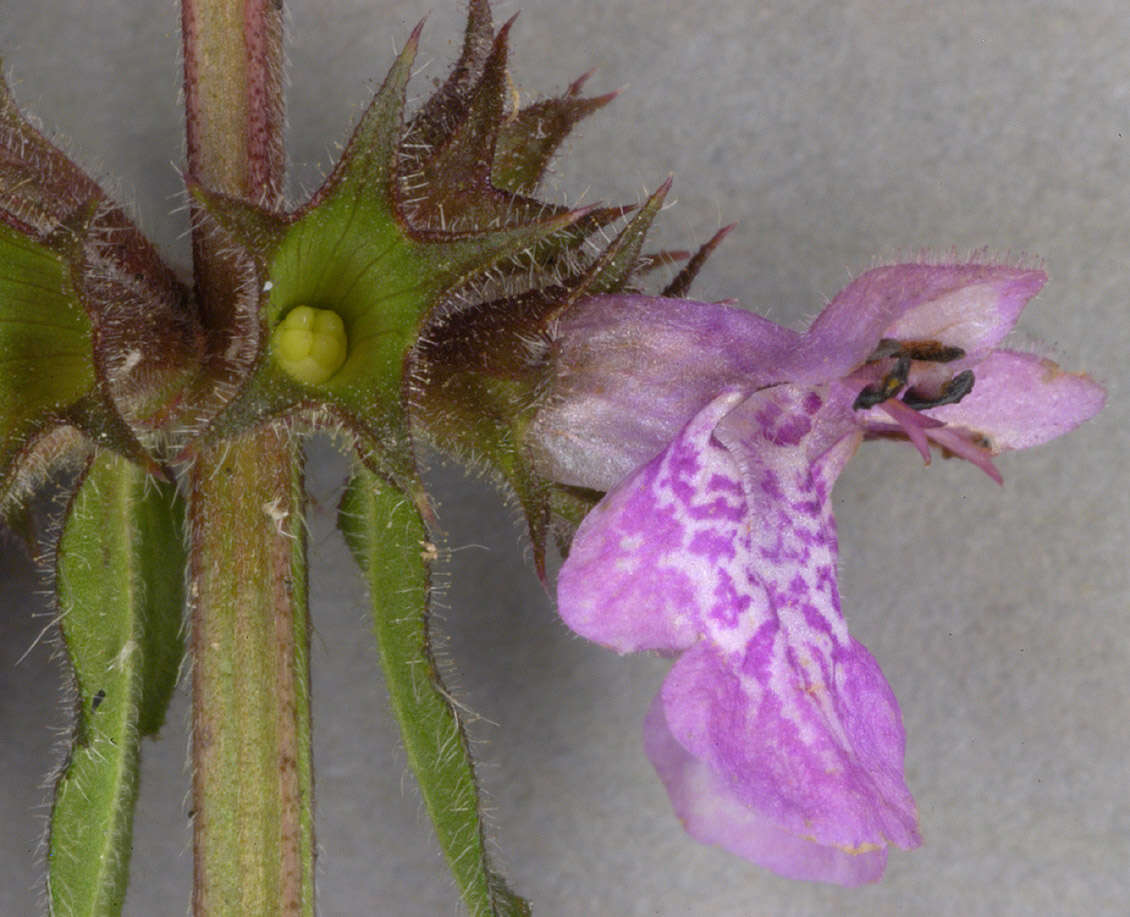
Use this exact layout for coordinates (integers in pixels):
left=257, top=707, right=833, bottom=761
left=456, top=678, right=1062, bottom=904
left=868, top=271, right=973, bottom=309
left=339, top=468, right=530, bottom=917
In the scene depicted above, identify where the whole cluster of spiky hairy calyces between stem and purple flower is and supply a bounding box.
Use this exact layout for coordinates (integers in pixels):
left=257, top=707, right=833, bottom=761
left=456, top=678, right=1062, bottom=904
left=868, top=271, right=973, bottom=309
left=190, top=0, right=718, bottom=571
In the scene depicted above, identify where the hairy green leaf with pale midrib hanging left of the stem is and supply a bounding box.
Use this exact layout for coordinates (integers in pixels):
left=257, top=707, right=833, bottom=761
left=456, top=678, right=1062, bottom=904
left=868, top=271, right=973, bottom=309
left=47, top=451, right=185, bottom=917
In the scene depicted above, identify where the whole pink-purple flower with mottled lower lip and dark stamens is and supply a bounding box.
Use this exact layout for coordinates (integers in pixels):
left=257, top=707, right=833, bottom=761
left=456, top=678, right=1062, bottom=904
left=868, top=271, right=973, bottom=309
left=533, top=264, right=1104, bottom=885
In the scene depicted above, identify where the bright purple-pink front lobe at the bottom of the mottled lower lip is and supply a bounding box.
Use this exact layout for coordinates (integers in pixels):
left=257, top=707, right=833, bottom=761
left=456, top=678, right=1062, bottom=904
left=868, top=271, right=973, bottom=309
left=660, top=628, right=921, bottom=871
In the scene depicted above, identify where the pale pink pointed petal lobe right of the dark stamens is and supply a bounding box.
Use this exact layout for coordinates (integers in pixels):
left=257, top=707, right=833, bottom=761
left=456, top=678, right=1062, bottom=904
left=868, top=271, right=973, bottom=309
left=927, top=350, right=1106, bottom=455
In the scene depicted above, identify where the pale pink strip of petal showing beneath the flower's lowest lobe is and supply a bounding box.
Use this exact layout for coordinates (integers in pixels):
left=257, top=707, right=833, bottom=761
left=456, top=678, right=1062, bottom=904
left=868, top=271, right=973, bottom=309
left=644, top=696, right=887, bottom=885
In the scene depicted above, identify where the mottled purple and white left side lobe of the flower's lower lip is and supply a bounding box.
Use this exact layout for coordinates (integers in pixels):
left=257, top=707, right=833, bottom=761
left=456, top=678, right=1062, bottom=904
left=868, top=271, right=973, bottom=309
left=557, top=392, right=746, bottom=653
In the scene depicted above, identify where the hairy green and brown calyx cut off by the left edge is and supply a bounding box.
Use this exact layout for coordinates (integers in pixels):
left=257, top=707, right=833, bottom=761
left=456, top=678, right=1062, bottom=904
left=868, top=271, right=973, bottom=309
left=0, top=68, right=199, bottom=516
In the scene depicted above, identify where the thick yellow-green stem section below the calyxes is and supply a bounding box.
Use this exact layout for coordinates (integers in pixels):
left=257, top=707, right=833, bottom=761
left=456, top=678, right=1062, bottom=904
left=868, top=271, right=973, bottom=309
left=189, top=430, right=314, bottom=917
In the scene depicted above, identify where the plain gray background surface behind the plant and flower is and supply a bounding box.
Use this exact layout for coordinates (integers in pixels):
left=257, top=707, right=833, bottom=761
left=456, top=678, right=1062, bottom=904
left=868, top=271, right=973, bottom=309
left=0, top=0, right=1130, bottom=917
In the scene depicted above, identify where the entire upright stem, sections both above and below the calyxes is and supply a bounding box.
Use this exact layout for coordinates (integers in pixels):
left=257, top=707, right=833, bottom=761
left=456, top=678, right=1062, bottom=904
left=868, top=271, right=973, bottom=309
left=182, top=0, right=314, bottom=917
